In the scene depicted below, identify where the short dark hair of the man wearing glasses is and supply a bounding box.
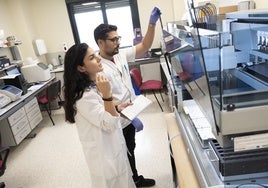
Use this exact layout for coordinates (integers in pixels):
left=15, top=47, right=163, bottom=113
left=94, top=24, right=117, bottom=44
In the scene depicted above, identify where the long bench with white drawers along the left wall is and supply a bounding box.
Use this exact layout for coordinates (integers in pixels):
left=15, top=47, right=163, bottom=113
left=0, top=76, right=55, bottom=146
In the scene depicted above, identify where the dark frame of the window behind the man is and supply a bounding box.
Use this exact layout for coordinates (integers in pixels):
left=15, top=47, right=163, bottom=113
left=65, top=0, right=140, bottom=44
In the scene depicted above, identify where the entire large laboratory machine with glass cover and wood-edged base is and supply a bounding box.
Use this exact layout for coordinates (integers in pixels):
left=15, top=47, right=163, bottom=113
left=161, top=14, right=268, bottom=188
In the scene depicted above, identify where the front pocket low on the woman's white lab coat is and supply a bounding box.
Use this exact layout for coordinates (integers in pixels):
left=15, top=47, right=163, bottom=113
left=104, top=152, right=127, bottom=180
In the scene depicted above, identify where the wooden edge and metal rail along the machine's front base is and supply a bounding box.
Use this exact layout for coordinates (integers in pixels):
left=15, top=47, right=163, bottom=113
left=166, top=100, right=268, bottom=188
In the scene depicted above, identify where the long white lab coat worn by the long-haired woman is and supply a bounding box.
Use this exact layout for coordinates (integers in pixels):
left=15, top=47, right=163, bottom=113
left=75, top=88, right=136, bottom=188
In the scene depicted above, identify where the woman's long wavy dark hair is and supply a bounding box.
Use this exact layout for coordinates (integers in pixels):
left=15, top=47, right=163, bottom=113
left=63, top=43, right=92, bottom=123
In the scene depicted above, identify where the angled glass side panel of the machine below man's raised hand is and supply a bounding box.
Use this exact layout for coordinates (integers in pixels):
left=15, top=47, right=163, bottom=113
left=164, top=21, right=220, bottom=135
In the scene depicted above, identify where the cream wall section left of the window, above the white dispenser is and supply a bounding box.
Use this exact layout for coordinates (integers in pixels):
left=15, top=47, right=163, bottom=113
left=24, top=0, right=74, bottom=52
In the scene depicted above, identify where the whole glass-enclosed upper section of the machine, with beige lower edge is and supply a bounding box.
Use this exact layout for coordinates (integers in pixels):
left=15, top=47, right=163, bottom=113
left=163, top=3, right=268, bottom=146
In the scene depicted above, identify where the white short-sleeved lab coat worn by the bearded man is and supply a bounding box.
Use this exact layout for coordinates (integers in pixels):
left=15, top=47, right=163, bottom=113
left=101, top=46, right=136, bottom=128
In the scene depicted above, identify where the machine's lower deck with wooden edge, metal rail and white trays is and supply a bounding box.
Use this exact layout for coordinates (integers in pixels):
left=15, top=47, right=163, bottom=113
left=160, top=48, right=268, bottom=188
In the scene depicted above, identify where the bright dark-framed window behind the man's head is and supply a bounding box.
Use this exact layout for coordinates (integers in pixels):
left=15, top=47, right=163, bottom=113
left=66, top=0, right=140, bottom=50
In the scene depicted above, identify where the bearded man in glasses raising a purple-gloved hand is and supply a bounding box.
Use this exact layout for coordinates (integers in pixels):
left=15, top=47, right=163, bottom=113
left=94, top=7, right=161, bottom=187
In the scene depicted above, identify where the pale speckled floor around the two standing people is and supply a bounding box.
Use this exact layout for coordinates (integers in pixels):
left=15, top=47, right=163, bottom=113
left=0, top=95, right=174, bottom=188
